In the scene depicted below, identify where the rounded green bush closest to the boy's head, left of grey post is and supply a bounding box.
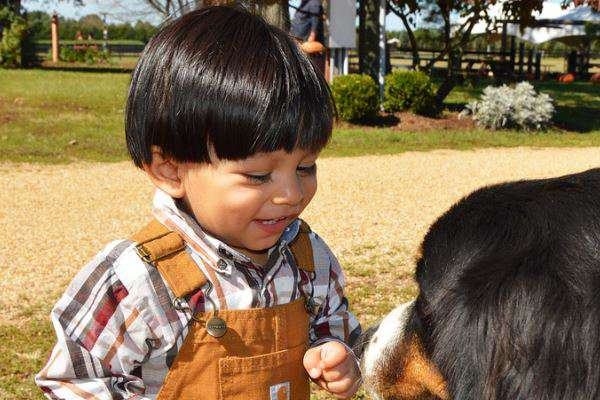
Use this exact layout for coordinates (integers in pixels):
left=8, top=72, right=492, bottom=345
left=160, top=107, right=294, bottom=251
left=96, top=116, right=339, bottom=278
left=331, top=74, right=379, bottom=122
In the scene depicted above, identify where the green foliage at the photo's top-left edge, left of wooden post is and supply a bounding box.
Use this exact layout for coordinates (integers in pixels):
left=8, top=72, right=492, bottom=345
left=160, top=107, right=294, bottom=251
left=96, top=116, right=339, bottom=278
left=0, top=6, right=28, bottom=67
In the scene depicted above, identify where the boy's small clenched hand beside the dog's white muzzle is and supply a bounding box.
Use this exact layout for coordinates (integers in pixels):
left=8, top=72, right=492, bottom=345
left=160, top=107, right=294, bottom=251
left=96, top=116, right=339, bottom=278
left=304, top=341, right=361, bottom=399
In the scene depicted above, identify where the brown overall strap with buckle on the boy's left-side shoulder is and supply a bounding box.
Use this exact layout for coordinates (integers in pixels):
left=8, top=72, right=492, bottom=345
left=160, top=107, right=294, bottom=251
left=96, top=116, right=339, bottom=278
left=131, top=219, right=207, bottom=297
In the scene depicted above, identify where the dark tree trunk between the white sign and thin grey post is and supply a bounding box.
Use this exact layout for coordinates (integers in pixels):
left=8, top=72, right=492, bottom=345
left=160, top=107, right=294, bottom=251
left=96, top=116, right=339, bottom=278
left=358, top=0, right=379, bottom=82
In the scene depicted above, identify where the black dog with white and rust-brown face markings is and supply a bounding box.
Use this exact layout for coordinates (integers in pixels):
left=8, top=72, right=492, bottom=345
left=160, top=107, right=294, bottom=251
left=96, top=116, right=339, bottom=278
left=354, top=169, right=600, bottom=400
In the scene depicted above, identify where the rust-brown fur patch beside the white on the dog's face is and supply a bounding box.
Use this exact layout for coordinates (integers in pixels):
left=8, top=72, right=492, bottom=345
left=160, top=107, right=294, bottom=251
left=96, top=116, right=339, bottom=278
left=385, top=334, right=449, bottom=400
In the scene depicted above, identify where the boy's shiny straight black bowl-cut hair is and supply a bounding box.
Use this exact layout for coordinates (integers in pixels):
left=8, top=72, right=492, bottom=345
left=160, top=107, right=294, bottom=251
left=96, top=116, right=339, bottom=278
left=125, top=6, right=336, bottom=167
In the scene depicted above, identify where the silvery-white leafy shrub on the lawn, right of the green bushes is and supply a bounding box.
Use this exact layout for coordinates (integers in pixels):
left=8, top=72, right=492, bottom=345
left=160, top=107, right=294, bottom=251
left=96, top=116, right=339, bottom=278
left=460, top=82, right=554, bottom=130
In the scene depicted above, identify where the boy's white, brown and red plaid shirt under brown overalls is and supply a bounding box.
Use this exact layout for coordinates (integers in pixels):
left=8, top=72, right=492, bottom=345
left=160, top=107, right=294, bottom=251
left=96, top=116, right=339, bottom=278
left=35, top=191, right=360, bottom=399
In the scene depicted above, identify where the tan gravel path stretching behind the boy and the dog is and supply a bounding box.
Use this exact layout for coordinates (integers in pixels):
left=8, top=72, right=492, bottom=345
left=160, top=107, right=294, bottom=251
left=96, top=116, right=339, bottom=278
left=0, top=148, right=600, bottom=325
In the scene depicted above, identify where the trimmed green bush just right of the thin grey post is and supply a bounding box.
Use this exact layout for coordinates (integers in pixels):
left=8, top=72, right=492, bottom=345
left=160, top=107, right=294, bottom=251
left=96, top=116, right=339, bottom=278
left=383, top=71, right=439, bottom=116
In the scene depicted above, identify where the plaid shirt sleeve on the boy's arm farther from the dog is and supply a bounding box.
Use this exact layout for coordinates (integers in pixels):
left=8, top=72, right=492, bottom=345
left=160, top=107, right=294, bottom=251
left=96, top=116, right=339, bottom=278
left=35, top=243, right=153, bottom=400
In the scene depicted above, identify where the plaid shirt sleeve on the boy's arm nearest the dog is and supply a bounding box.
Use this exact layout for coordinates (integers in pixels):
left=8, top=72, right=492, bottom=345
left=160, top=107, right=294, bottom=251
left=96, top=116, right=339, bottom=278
left=309, top=234, right=361, bottom=348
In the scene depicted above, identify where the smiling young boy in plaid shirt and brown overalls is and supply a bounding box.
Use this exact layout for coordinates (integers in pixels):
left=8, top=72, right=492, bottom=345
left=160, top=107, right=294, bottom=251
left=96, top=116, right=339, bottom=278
left=36, top=7, right=360, bottom=400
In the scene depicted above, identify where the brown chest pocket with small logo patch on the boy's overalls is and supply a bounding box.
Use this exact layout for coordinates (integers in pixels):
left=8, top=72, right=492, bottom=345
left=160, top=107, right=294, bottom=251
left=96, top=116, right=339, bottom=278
left=219, top=344, right=310, bottom=400
